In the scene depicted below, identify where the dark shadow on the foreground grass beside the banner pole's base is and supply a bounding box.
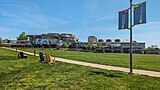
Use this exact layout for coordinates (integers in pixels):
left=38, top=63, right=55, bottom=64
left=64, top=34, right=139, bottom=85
left=89, top=71, right=122, bottom=78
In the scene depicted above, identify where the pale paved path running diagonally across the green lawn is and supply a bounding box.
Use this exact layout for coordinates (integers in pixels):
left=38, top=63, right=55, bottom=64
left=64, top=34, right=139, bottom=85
left=3, top=47, right=160, bottom=77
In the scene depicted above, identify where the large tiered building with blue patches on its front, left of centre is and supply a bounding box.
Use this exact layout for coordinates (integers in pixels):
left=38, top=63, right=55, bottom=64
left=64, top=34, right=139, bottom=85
left=27, top=33, right=79, bottom=45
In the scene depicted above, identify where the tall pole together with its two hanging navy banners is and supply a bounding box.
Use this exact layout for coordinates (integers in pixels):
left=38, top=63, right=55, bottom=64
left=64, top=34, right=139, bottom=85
left=118, top=0, right=146, bottom=74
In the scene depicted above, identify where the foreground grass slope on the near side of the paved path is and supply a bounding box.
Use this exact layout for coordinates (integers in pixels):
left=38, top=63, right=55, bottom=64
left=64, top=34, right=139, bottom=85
left=0, top=48, right=160, bottom=90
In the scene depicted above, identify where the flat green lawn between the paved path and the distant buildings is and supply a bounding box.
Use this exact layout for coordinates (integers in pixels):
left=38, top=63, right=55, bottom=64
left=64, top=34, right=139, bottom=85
left=22, top=49, right=160, bottom=72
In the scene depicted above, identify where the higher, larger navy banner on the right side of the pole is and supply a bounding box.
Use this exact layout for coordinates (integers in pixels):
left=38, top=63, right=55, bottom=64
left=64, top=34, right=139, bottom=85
left=134, top=2, right=146, bottom=25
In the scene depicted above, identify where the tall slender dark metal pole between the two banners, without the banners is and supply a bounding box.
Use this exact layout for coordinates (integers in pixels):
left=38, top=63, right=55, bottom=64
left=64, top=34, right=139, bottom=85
left=130, top=0, right=133, bottom=74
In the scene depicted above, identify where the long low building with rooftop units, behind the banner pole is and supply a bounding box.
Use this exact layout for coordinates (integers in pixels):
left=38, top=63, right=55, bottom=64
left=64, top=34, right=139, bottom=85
left=76, top=39, right=145, bottom=53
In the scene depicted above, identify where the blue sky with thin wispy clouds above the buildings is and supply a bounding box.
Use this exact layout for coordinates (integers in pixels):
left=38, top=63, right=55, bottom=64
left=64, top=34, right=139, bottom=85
left=0, top=0, right=160, bottom=47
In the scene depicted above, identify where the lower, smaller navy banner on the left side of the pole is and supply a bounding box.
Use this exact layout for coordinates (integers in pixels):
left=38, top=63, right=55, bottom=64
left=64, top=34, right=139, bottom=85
left=118, top=10, right=128, bottom=30
